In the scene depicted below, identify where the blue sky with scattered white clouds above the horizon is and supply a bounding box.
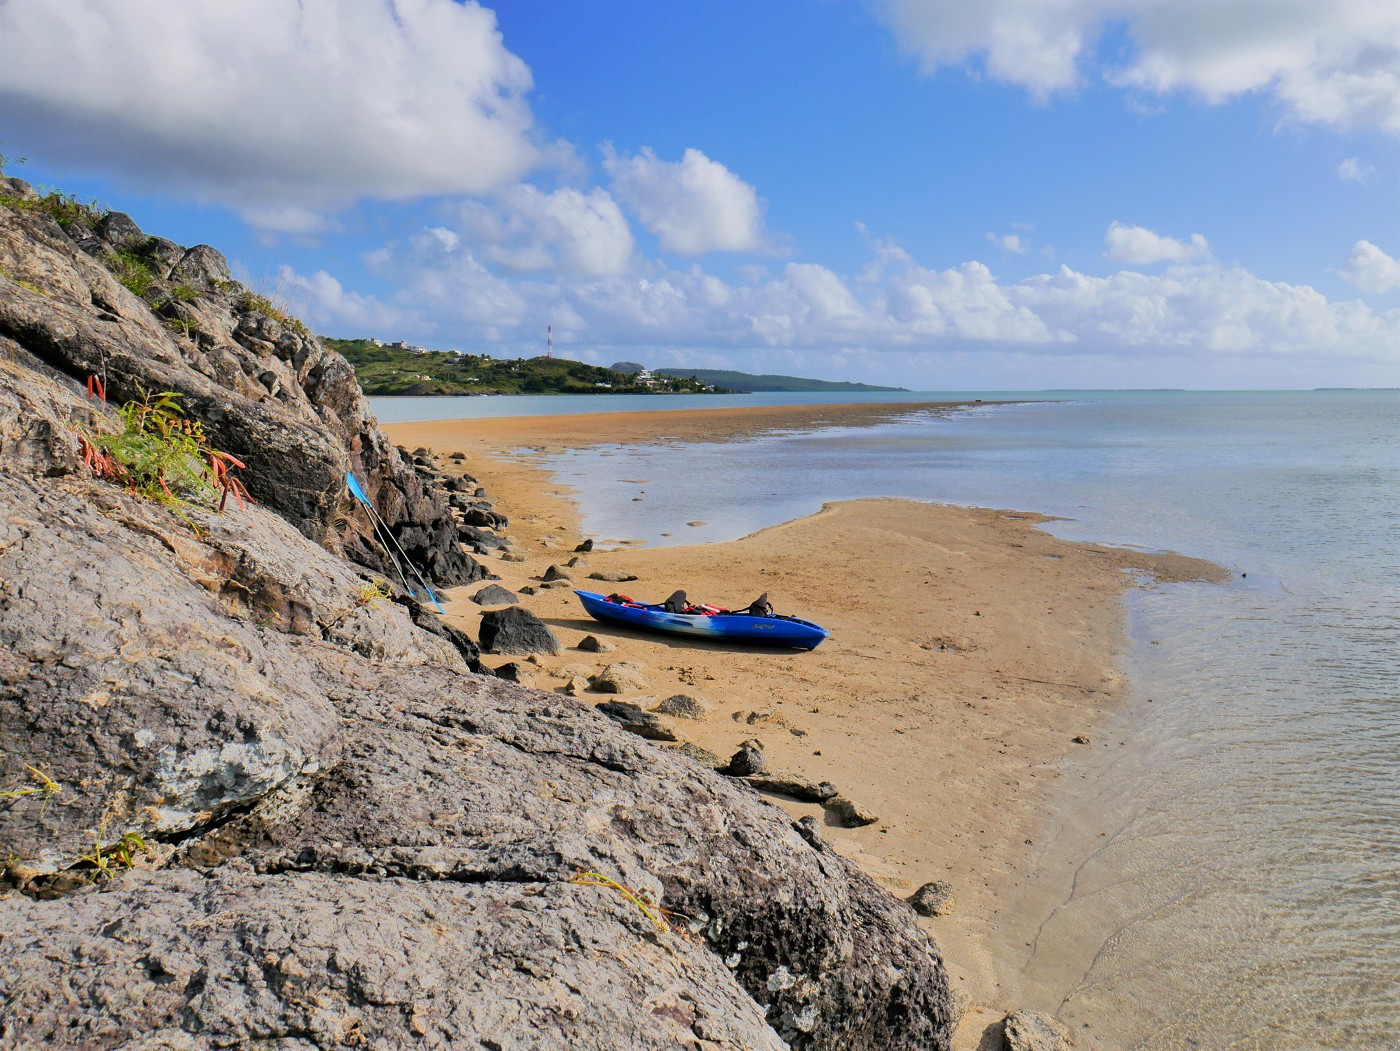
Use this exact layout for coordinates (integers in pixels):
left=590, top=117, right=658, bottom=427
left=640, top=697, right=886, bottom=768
left=0, top=0, right=1400, bottom=390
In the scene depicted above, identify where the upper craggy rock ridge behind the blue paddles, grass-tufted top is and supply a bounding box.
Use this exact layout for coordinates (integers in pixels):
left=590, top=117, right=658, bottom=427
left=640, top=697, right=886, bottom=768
left=0, top=178, right=486, bottom=585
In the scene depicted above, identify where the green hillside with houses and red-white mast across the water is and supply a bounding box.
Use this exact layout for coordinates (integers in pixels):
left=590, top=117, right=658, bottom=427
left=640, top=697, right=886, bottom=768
left=322, top=337, right=715, bottom=395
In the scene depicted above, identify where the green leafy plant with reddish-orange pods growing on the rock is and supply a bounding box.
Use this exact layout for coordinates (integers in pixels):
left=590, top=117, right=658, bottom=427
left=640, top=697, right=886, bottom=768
left=80, top=376, right=252, bottom=532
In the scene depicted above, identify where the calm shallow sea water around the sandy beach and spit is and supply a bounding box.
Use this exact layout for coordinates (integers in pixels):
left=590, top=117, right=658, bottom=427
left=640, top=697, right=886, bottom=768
left=372, top=390, right=1400, bottom=1051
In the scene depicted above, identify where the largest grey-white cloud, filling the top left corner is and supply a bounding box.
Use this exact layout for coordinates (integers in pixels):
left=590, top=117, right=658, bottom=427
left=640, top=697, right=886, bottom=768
left=0, top=0, right=543, bottom=222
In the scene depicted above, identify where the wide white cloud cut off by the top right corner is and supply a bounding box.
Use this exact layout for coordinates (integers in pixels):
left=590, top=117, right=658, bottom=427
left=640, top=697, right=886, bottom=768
left=882, top=0, right=1400, bottom=133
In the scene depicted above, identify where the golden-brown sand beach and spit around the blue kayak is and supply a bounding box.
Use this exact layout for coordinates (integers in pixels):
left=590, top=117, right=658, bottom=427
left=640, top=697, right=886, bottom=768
left=385, top=404, right=1221, bottom=1048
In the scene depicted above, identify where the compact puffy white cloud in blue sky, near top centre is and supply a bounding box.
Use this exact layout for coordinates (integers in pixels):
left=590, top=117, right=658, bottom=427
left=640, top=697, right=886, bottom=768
left=603, top=146, right=766, bottom=255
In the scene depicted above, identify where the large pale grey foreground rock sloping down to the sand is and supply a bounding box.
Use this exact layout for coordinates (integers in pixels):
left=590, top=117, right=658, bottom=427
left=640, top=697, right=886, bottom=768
left=0, top=184, right=951, bottom=1051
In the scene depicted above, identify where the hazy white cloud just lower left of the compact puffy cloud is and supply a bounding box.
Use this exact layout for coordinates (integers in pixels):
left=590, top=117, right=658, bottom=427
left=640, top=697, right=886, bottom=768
left=455, top=185, right=633, bottom=277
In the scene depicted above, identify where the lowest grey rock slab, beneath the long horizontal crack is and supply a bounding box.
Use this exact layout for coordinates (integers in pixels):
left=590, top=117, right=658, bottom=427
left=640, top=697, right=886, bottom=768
left=0, top=866, right=784, bottom=1051
